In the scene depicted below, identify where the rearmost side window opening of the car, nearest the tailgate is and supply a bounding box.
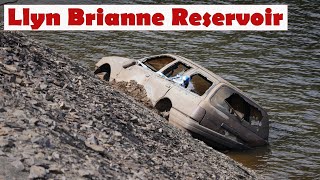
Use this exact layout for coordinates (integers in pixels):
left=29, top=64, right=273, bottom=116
left=187, top=74, right=213, bottom=96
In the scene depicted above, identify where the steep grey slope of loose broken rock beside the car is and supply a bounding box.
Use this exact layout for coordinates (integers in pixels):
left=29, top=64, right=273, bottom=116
left=0, top=31, right=257, bottom=179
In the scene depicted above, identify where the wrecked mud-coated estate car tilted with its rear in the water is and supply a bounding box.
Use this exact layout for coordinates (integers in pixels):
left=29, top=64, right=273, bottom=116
left=95, top=54, right=269, bottom=149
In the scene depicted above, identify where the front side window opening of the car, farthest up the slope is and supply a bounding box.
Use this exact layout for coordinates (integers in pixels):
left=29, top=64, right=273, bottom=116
left=143, top=56, right=175, bottom=72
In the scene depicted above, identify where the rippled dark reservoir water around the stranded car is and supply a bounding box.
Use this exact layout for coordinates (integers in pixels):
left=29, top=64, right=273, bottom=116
left=1, top=0, right=320, bottom=179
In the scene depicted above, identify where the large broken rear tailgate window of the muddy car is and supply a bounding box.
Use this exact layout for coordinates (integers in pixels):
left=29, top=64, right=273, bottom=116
left=211, top=86, right=262, bottom=125
